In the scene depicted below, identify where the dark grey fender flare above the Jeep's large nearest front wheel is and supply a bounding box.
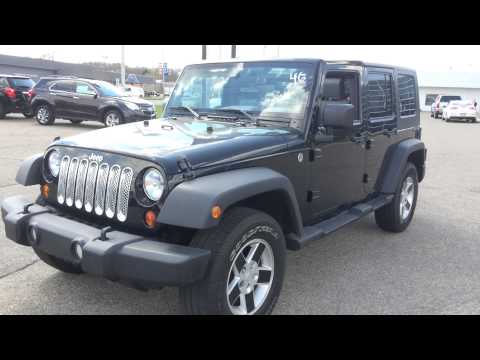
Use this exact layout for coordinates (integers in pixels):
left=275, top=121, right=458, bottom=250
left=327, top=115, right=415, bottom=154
left=157, top=167, right=303, bottom=235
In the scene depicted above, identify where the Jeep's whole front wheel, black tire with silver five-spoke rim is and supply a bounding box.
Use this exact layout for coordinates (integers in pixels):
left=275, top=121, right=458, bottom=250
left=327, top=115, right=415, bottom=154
left=180, top=207, right=286, bottom=315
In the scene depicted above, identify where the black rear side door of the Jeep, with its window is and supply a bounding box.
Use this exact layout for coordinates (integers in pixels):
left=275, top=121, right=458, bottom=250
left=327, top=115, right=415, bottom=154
left=363, top=67, right=397, bottom=193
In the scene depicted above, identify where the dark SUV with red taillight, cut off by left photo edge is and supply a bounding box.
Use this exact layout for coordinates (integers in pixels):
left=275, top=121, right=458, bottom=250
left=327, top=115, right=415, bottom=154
left=0, top=74, right=35, bottom=119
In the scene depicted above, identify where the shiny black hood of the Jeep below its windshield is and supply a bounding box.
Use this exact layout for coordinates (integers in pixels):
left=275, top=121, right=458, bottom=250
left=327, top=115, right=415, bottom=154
left=53, top=118, right=299, bottom=173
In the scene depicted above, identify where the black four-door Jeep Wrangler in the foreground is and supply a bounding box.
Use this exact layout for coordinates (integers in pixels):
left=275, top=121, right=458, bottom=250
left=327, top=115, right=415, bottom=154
left=2, top=59, right=426, bottom=314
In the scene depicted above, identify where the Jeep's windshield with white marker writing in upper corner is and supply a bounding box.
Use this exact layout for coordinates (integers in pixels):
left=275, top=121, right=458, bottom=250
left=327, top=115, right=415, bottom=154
left=166, top=61, right=314, bottom=128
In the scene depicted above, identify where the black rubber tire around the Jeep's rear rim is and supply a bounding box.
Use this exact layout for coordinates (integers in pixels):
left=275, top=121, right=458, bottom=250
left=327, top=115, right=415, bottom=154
left=375, top=162, right=418, bottom=232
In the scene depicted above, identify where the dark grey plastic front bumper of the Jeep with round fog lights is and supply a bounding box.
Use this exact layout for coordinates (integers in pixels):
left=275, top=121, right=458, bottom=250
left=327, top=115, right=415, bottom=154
left=1, top=197, right=210, bottom=288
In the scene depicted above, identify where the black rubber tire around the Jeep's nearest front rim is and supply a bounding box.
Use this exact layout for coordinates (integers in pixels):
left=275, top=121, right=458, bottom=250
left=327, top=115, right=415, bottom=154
left=180, top=207, right=286, bottom=315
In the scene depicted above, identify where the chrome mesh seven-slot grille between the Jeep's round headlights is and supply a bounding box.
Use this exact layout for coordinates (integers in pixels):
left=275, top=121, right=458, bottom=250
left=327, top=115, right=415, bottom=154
left=57, top=155, right=133, bottom=222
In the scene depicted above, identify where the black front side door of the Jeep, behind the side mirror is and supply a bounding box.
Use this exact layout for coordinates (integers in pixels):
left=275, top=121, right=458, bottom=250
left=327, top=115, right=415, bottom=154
left=310, top=67, right=365, bottom=218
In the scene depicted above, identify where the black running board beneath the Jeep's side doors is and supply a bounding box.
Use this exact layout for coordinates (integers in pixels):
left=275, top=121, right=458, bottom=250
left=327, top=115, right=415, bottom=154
left=287, top=195, right=393, bottom=250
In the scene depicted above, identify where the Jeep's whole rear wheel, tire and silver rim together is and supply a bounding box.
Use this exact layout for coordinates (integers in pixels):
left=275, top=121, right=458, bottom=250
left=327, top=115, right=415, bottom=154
left=375, top=162, right=418, bottom=232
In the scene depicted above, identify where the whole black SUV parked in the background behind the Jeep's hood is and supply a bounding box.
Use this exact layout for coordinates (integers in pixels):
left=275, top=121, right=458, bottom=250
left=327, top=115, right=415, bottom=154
left=30, top=78, right=156, bottom=126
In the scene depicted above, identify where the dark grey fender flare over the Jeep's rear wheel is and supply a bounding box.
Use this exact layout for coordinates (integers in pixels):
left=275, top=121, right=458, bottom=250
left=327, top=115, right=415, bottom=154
left=379, top=139, right=426, bottom=194
